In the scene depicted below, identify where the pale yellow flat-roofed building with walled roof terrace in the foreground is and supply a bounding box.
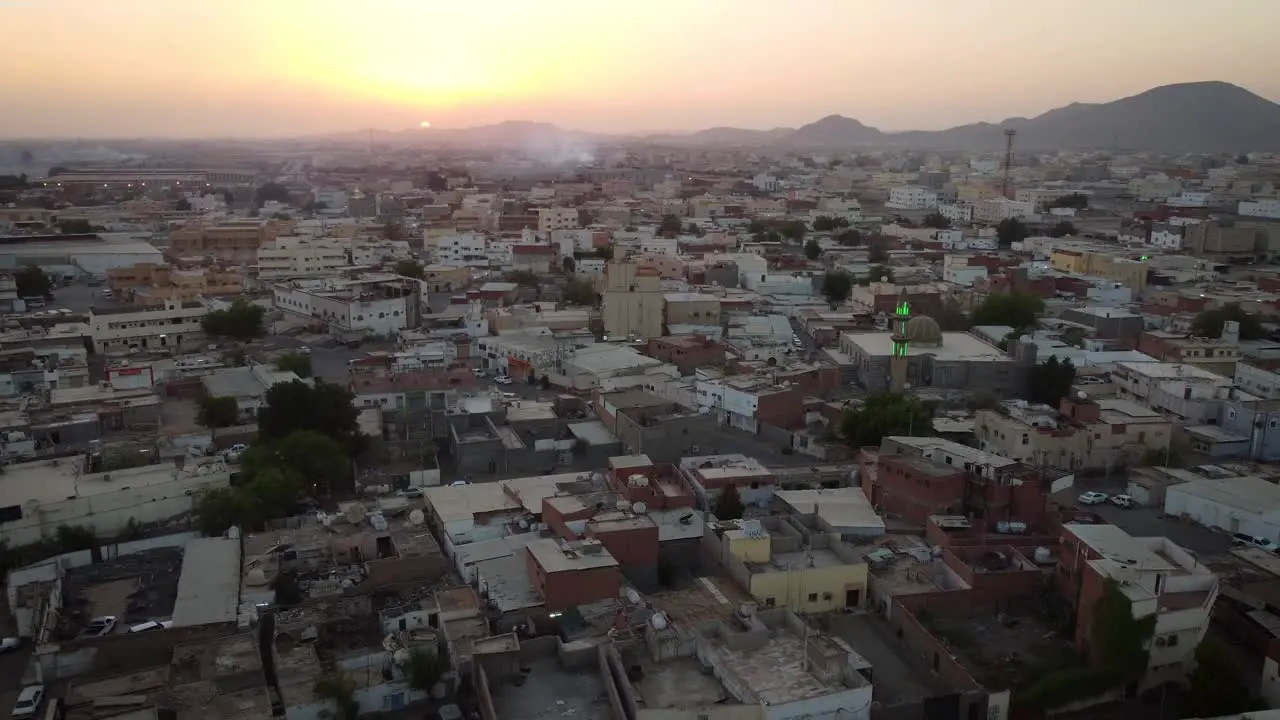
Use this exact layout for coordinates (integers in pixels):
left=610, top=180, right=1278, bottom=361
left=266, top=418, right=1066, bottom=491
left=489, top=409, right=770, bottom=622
left=708, top=516, right=867, bottom=612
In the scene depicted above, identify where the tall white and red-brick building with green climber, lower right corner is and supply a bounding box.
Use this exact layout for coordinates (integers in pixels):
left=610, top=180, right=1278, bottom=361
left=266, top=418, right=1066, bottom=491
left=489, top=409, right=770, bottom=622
left=1057, top=523, right=1219, bottom=688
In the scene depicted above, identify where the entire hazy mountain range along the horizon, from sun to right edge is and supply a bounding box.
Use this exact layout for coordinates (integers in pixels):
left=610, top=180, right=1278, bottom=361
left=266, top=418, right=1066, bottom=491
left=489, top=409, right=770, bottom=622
left=406, top=82, right=1280, bottom=152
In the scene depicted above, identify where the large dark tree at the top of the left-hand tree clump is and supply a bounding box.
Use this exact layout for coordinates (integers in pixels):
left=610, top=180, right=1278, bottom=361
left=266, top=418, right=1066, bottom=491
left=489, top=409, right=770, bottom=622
left=257, top=378, right=360, bottom=455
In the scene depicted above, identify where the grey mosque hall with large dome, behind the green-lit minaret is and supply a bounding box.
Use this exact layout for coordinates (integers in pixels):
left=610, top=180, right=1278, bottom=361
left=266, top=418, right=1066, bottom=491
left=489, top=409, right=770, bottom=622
left=840, top=315, right=1034, bottom=397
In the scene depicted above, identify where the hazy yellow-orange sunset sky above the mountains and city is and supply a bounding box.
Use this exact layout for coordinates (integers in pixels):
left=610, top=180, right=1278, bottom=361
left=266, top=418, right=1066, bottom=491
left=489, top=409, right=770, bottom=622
left=0, top=0, right=1280, bottom=137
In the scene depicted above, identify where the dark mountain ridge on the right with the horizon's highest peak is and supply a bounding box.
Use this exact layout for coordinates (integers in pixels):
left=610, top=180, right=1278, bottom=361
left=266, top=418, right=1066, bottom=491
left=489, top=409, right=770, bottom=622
left=783, top=82, right=1280, bottom=152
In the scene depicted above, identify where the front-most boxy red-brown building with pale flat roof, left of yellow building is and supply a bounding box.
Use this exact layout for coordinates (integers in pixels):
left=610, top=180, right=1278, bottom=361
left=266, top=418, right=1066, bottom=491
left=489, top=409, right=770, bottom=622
left=525, top=538, right=622, bottom=612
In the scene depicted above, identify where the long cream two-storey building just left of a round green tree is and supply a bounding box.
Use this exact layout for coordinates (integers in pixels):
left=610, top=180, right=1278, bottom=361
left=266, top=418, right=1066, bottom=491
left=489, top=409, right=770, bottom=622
left=88, top=300, right=209, bottom=354
